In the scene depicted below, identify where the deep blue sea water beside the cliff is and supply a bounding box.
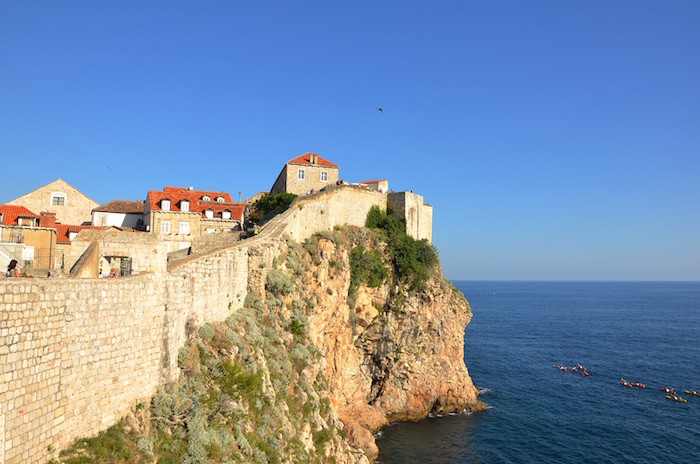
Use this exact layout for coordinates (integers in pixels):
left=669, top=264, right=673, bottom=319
left=377, top=282, right=700, bottom=464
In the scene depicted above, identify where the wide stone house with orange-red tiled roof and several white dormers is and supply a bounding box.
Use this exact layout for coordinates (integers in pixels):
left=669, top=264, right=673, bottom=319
left=143, top=187, right=250, bottom=251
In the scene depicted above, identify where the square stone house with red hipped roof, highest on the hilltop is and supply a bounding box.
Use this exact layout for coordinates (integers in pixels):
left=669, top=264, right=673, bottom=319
left=270, top=152, right=340, bottom=195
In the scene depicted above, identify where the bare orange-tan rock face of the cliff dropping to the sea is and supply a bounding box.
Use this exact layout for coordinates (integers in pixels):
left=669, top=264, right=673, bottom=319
left=266, top=229, right=484, bottom=459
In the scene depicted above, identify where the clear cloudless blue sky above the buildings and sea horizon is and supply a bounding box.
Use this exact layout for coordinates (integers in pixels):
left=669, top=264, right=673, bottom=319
left=0, top=0, right=700, bottom=280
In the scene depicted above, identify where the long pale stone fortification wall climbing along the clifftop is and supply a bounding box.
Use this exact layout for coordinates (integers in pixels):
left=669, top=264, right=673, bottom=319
left=0, top=186, right=432, bottom=464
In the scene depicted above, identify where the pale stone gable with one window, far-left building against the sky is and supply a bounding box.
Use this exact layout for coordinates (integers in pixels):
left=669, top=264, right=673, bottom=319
left=7, top=179, right=99, bottom=225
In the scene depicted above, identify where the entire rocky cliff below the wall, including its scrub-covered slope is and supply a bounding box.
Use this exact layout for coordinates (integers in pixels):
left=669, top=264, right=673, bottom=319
left=54, top=227, right=483, bottom=463
